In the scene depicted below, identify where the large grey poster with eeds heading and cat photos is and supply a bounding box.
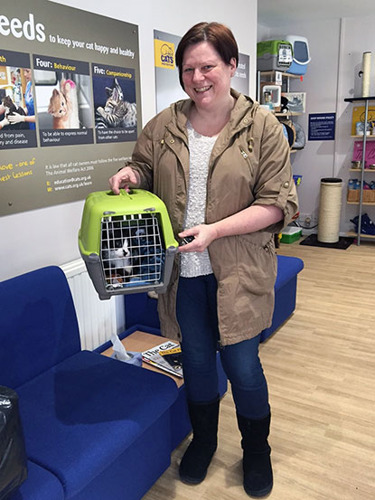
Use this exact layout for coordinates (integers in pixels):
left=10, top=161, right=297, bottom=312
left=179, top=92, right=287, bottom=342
left=0, top=0, right=142, bottom=215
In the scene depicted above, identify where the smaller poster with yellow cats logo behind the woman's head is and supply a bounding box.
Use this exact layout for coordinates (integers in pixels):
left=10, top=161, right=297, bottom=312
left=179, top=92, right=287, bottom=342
left=154, top=30, right=250, bottom=113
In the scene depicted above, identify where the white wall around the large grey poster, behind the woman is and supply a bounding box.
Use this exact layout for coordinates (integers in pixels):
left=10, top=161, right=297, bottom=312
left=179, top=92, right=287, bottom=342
left=0, top=0, right=257, bottom=280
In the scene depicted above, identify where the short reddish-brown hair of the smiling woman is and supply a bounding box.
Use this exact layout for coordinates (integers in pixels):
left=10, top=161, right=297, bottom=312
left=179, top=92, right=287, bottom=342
left=176, top=22, right=238, bottom=88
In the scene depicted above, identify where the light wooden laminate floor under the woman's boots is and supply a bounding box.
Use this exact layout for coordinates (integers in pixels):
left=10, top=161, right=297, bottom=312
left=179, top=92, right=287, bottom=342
left=144, top=242, right=375, bottom=500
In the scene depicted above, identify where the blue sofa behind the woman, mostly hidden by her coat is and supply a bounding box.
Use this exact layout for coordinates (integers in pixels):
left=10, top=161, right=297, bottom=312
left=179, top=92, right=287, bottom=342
left=124, top=255, right=304, bottom=342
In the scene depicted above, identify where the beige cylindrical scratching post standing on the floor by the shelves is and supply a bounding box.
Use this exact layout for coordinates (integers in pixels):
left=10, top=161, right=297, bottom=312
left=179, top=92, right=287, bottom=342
left=318, top=177, right=342, bottom=243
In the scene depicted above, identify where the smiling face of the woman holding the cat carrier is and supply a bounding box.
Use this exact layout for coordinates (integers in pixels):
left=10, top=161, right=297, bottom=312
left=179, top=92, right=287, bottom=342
left=182, top=42, right=236, bottom=110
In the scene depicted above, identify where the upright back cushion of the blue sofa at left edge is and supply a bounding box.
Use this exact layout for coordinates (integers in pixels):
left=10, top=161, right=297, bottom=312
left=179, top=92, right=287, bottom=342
left=0, top=266, right=80, bottom=389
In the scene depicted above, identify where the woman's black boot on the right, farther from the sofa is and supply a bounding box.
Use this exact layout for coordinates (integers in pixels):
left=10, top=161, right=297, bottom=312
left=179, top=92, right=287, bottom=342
left=237, top=413, right=273, bottom=498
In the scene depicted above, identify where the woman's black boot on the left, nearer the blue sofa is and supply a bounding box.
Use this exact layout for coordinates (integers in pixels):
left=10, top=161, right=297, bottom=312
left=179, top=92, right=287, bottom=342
left=179, top=396, right=220, bottom=484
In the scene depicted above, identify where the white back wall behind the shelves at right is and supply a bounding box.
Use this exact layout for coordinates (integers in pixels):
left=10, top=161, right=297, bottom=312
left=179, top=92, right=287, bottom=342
left=258, top=15, right=375, bottom=234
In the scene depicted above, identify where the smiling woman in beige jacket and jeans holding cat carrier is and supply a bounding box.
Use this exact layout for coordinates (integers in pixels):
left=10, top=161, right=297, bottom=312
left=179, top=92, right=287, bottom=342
left=109, top=23, right=298, bottom=497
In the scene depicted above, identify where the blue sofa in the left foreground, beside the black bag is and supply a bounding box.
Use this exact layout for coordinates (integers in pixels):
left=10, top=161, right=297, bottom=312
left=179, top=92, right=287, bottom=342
left=0, top=266, right=179, bottom=500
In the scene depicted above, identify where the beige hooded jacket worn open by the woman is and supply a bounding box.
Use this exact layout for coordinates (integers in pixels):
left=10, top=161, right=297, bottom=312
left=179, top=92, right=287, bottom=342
left=127, top=90, right=298, bottom=345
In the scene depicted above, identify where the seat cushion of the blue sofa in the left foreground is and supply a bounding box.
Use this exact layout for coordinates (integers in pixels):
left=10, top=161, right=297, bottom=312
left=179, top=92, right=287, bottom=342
left=18, top=351, right=178, bottom=498
